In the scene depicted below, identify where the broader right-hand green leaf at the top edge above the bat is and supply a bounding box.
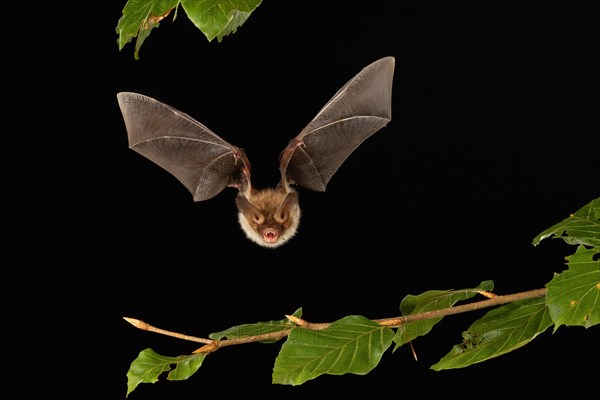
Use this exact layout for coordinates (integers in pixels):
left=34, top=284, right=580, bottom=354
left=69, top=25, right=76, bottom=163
left=181, top=0, right=262, bottom=42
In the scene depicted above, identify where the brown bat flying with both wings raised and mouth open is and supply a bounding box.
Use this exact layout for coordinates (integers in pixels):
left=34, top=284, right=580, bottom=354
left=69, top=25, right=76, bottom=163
left=117, top=57, right=395, bottom=248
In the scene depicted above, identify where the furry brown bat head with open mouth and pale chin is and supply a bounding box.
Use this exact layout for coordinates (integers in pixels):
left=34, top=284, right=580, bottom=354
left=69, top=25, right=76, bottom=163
left=236, top=188, right=300, bottom=248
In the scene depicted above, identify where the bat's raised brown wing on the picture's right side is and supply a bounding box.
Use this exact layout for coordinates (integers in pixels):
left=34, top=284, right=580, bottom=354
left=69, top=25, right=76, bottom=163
left=279, top=57, right=395, bottom=192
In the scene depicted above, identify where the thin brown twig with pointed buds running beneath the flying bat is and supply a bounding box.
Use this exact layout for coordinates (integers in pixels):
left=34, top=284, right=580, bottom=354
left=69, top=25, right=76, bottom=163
left=123, top=288, right=546, bottom=353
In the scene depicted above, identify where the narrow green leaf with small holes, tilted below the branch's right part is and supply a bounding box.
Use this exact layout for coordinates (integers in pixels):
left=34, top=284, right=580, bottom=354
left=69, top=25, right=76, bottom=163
left=431, top=297, right=552, bottom=371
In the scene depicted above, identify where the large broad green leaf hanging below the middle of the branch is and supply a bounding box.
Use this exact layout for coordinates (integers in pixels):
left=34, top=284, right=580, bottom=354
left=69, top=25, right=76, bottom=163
left=273, top=315, right=394, bottom=385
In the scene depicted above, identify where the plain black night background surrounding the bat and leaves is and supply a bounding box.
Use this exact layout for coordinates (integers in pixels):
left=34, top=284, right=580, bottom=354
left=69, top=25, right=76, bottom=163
left=3, top=1, right=600, bottom=399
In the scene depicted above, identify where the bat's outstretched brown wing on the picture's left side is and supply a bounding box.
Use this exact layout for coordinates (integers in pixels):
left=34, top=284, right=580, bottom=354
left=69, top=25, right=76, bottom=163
left=117, top=92, right=250, bottom=201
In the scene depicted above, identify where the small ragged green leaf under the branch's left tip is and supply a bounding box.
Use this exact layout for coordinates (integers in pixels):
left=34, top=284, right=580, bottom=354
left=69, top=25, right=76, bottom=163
left=126, top=349, right=206, bottom=397
